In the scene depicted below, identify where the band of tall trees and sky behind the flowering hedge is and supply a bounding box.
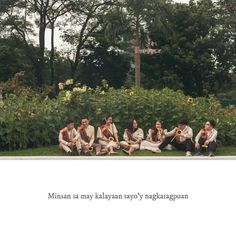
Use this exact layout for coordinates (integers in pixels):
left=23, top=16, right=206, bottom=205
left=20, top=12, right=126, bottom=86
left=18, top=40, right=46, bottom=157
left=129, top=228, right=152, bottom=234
left=0, top=0, right=236, bottom=96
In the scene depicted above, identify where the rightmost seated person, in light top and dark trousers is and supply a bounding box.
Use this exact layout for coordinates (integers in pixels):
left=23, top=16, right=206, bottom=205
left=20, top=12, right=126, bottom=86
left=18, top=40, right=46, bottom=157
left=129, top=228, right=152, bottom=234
left=195, top=120, right=217, bottom=156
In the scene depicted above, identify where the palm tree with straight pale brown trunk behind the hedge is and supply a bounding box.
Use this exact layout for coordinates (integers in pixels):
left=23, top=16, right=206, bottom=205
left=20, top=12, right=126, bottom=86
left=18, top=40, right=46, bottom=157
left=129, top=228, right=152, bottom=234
left=102, top=0, right=171, bottom=86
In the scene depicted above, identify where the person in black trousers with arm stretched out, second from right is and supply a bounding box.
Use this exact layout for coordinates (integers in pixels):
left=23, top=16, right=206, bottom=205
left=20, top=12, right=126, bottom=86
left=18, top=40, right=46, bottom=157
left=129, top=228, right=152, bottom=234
left=159, top=119, right=194, bottom=156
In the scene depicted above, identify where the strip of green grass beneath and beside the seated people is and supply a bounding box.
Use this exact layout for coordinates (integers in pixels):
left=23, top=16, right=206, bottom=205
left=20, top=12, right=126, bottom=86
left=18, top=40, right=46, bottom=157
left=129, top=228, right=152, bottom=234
left=0, top=146, right=236, bottom=156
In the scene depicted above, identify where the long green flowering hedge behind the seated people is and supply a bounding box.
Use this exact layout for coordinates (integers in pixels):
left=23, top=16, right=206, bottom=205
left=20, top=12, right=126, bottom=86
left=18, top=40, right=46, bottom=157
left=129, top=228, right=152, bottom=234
left=0, top=84, right=236, bottom=150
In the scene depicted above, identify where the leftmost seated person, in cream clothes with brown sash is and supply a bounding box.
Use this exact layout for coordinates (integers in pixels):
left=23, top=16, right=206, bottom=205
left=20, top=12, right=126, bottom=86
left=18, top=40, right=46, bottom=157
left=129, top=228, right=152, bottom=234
left=58, top=120, right=81, bottom=155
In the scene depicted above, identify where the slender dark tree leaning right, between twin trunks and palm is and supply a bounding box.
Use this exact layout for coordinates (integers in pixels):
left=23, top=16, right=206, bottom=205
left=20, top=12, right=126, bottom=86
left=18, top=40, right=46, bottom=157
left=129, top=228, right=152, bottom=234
left=60, top=0, right=116, bottom=78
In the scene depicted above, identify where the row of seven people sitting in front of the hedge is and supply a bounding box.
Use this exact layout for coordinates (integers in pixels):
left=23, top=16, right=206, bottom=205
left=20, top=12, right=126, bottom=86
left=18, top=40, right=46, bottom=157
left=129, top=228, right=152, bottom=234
left=59, top=116, right=217, bottom=156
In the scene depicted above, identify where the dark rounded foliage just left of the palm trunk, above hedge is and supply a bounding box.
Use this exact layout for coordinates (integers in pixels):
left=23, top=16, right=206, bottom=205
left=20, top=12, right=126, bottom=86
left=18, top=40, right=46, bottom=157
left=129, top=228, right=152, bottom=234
left=77, top=38, right=130, bottom=88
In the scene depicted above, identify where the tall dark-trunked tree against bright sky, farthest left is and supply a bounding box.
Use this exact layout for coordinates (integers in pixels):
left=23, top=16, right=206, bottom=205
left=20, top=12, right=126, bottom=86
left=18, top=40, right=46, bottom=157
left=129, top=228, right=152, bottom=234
left=1, top=0, right=71, bottom=86
